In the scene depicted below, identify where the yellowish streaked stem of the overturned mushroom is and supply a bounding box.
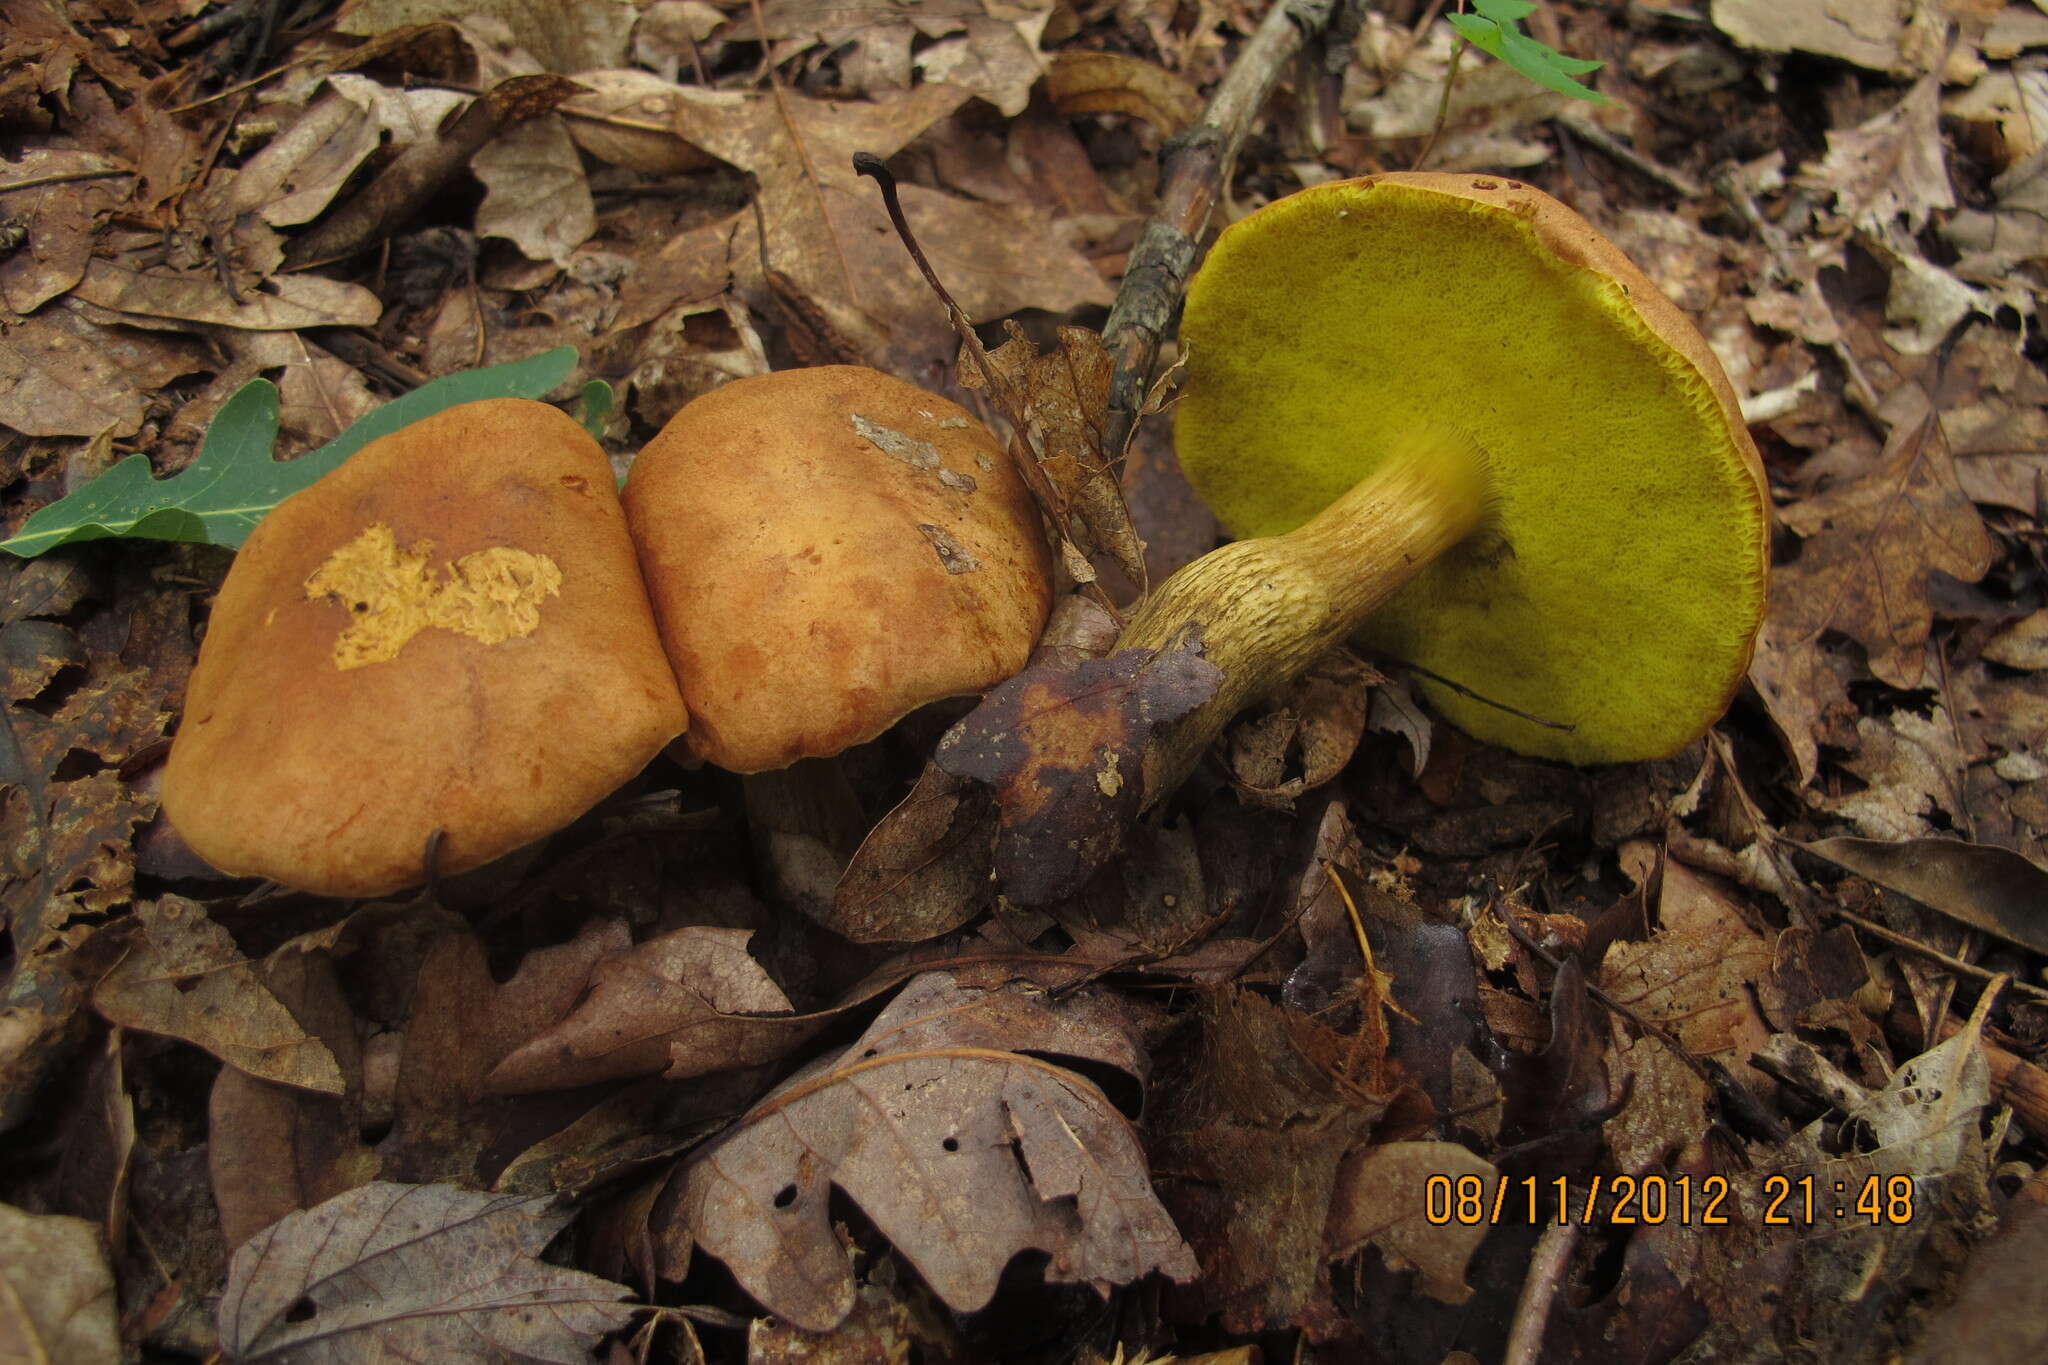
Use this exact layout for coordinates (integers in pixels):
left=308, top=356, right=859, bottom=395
left=1116, top=428, right=1491, bottom=806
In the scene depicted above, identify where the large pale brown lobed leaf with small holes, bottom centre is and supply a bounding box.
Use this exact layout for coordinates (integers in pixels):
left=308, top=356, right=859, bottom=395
left=680, top=972, right=1194, bottom=1332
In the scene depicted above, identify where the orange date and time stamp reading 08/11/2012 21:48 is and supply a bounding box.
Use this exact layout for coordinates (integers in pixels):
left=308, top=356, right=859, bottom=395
left=1423, top=1175, right=1915, bottom=1228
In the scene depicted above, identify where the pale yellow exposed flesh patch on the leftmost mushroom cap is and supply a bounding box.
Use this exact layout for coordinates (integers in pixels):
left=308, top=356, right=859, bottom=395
left=305, top=524, right=561, bottom=669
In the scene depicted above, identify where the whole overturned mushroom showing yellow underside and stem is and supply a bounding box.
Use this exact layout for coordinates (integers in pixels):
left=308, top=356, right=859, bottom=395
left=1120, top=174, right=1769, bottom=802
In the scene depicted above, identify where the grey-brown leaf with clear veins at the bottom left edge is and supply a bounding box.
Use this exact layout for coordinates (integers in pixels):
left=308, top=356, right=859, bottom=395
left=219, top=1181, right=633, bottom=1365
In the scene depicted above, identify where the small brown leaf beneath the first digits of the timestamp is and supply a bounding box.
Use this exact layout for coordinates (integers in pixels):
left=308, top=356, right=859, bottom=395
left=1323, top=1142, right=1501, bottom=1304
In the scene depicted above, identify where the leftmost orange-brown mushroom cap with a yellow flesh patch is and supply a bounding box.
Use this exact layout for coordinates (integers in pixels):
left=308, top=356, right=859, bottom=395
left=164, top=399, right=686, bottom=896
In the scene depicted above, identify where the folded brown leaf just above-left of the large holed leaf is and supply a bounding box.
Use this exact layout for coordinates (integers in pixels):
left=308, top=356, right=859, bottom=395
left=483, top=925, right=815, bottom=1095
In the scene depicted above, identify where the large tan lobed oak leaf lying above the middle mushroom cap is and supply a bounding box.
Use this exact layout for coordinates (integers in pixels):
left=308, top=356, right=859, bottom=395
left=643, top=86, right=1110, bottom=385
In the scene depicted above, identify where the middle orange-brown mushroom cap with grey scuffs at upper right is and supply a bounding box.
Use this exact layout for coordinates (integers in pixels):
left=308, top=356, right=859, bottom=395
left=625, top=364, right=1053, bottom=772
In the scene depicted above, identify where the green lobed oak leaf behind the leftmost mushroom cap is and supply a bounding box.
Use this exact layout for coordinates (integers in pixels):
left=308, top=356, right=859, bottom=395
left=0, top=346, right=588, bottom=559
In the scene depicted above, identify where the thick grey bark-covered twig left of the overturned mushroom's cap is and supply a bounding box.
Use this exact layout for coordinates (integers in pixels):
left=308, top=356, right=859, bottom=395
left=1102, top=0, right=1356, bottom=460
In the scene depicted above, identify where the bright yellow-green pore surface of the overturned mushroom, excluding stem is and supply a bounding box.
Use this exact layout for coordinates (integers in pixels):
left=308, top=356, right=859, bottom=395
left=1176, top=182, right=1767, bottom=763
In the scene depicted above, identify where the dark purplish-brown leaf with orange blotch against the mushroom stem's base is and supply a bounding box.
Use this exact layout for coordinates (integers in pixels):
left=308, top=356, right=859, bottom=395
left=934, top=649, right=1223, bottom=905
